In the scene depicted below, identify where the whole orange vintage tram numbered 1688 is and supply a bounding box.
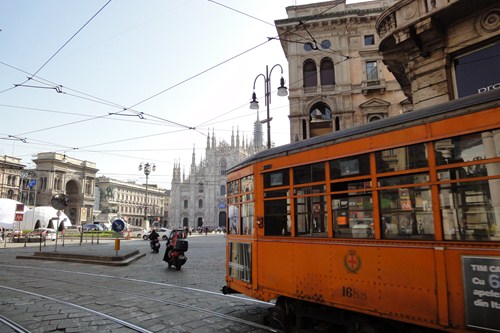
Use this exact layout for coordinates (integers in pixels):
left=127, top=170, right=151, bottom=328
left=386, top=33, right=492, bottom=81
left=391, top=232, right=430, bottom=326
left=223, top=89, right=500, bottom=333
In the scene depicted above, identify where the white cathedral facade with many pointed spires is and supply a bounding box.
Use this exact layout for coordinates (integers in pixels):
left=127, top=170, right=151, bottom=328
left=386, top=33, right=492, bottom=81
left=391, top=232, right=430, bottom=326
left=170, top=129, right=265, bottom=228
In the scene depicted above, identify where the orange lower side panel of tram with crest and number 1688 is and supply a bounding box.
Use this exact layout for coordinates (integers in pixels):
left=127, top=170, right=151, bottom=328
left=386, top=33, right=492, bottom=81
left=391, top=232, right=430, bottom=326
left=256, top=241, right=439, bottom=326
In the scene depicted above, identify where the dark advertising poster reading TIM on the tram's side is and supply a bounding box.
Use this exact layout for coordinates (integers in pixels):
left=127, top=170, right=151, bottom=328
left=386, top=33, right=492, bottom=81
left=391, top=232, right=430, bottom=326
left=462, top=256, right=500, bottom=332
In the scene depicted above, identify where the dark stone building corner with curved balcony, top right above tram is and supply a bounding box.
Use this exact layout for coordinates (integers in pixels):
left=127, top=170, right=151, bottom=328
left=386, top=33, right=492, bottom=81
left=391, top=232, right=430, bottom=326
left=376, top=0, right=500, bottom=109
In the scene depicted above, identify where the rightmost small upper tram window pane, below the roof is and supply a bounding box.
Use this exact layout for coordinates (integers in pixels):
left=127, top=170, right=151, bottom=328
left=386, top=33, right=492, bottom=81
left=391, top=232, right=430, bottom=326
left=434, top=132, right=488, bottom=165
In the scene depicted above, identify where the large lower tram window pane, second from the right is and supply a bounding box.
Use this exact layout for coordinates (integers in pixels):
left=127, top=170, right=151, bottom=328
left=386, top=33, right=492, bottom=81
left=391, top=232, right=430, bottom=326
left=379, top=186, right=434, bottom=239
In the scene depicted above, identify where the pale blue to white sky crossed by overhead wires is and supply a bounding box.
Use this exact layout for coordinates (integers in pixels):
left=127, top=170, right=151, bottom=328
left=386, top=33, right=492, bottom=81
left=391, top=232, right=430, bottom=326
left=0, top=0, right=364, bottom=189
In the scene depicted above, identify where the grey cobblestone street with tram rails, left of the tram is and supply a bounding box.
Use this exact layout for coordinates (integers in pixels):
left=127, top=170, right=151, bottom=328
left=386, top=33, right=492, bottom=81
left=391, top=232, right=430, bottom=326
left=0, top=234, right=276, bottom=332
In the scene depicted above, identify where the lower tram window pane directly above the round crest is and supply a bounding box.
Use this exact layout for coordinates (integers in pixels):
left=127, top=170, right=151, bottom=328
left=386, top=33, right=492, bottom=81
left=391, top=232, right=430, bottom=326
left=332, top=193, right=374, bottom=238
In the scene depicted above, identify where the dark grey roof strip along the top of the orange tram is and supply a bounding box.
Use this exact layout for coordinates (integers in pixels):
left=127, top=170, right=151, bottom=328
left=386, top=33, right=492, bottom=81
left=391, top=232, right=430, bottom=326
left=229, top=89, right=500, bottom=171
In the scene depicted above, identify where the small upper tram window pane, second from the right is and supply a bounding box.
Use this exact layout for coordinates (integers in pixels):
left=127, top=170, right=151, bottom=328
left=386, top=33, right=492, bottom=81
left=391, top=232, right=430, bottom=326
left=375, top=143, right=428, bottom=172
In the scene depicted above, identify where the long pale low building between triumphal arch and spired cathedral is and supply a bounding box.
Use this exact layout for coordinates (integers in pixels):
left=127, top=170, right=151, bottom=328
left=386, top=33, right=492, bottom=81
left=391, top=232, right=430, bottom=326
left=96, top=176, right=169, bottom=228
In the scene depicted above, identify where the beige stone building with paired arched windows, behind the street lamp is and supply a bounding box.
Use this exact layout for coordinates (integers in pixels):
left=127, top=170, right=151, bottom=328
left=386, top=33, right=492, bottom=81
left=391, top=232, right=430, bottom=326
left=275, top=0, right=412, bottom=142
